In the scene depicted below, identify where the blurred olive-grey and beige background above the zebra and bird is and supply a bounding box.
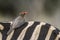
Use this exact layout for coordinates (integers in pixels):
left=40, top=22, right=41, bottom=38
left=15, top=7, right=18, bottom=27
left=0, top=0, right=60, bottom=29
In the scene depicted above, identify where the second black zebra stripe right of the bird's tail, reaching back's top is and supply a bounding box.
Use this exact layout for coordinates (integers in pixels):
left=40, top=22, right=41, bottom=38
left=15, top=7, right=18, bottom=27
left=23, top=22, right=39, bottom=40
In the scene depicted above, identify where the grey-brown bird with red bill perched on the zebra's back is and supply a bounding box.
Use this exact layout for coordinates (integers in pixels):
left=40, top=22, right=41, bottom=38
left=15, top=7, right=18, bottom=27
left=7, top=11, right=28, bottom=35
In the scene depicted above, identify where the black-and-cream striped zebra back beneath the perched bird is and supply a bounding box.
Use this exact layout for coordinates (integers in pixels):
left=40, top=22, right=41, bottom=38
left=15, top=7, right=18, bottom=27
left=0, top=21, right=60, bottom=40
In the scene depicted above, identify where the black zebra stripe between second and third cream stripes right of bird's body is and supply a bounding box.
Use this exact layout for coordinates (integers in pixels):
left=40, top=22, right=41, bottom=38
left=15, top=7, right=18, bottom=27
left=38, top=24, right=50, bottom=40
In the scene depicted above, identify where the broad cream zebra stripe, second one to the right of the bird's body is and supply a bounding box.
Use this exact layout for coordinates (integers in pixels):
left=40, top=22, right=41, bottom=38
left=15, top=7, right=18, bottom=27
left=30, top=22, right=45, bottom=40
